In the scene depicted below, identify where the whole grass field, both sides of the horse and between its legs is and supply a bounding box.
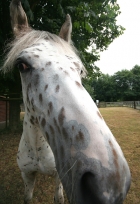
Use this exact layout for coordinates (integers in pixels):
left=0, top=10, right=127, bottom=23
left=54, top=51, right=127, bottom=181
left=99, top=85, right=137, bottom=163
left=0, top=108, right=140, bottom=204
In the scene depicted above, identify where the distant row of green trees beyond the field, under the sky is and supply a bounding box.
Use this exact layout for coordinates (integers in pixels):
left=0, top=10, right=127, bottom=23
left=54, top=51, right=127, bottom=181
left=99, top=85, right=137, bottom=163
left=92, top=65, right=140, bottom=102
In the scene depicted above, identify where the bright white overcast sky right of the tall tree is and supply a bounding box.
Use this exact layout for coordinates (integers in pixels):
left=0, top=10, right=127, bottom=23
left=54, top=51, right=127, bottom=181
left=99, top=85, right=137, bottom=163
left=95, top=0, right=140, bottom=75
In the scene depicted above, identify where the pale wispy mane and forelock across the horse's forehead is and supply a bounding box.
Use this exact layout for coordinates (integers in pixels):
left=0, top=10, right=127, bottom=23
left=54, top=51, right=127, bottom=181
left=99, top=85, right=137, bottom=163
left=2, top=29, right=86, bottom=77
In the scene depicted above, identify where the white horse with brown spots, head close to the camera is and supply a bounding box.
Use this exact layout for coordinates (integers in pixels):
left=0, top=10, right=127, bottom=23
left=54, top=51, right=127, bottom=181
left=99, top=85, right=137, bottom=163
left=3, top=0, right=131, bottom=204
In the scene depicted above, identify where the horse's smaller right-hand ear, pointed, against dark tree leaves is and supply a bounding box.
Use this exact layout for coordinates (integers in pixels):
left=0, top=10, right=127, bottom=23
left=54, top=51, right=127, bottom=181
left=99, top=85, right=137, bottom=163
left=59, top=14, right=72, bottom=43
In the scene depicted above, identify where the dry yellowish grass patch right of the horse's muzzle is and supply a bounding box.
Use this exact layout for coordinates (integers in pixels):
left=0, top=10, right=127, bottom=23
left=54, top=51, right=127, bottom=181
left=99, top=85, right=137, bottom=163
left=100, top=108, right=140, bottom=204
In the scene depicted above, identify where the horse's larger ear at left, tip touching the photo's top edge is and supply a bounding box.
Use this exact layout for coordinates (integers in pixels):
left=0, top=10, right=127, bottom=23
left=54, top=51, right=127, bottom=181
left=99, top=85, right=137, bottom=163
left=10, top=0, right=29, bottom=36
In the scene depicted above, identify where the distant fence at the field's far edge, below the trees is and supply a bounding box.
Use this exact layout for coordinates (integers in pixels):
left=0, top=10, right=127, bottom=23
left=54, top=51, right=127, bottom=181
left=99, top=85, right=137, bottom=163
left=99, top=101, right=140, bottom=110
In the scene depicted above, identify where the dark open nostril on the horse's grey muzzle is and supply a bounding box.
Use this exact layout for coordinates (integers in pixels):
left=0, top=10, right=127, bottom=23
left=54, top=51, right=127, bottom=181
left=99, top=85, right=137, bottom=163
left=81, top=172, right=102, bottom=204
